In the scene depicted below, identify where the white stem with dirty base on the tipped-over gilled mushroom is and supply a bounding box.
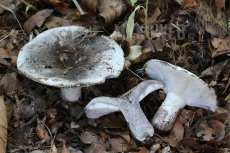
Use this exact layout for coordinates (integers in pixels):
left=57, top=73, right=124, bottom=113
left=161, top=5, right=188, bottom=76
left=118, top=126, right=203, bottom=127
left=151, top=92, right=186, bottom=132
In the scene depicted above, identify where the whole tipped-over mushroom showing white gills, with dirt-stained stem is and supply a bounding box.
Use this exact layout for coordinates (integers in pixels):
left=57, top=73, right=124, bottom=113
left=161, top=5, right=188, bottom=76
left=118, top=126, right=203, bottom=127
left=144, top=59, right=217, bottom=132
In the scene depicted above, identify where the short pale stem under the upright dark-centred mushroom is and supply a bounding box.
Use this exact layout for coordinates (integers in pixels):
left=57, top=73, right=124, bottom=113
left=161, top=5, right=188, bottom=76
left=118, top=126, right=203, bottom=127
left=61, top=87, right=81, bottom=102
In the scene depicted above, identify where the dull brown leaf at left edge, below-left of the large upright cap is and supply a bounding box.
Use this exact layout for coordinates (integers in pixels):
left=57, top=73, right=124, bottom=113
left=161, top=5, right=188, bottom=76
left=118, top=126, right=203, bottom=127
left=0, top=72, right=18, bottom=98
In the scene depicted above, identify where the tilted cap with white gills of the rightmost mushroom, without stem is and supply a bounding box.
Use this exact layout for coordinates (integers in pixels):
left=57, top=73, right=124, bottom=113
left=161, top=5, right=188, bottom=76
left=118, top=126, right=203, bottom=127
left=144, top=59, right=217, bottom=112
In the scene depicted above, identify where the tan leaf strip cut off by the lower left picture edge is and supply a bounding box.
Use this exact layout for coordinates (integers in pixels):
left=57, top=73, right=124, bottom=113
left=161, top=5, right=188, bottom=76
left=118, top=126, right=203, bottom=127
left=0, top=96, right=8, bottom=153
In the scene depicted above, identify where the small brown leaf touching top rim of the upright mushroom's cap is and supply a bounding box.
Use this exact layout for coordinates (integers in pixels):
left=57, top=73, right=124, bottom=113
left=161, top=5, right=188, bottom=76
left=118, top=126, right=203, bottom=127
left=44, top=16, right=72, bottom=29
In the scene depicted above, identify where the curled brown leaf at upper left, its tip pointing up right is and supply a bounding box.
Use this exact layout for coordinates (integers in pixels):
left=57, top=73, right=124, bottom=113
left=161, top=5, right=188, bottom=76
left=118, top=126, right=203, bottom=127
left=23, top=9, right=53, bottom=33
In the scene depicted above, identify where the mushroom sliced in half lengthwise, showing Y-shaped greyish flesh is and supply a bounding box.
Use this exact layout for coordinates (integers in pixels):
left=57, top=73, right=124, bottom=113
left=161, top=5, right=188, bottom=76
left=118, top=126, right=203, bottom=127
left=85, top=80, right=164, bottom=143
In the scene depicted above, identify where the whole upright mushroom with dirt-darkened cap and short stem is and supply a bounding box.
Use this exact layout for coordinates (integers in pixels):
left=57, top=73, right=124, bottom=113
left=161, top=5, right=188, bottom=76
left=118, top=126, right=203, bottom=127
left=17, top=26, right=124, bottom=101
